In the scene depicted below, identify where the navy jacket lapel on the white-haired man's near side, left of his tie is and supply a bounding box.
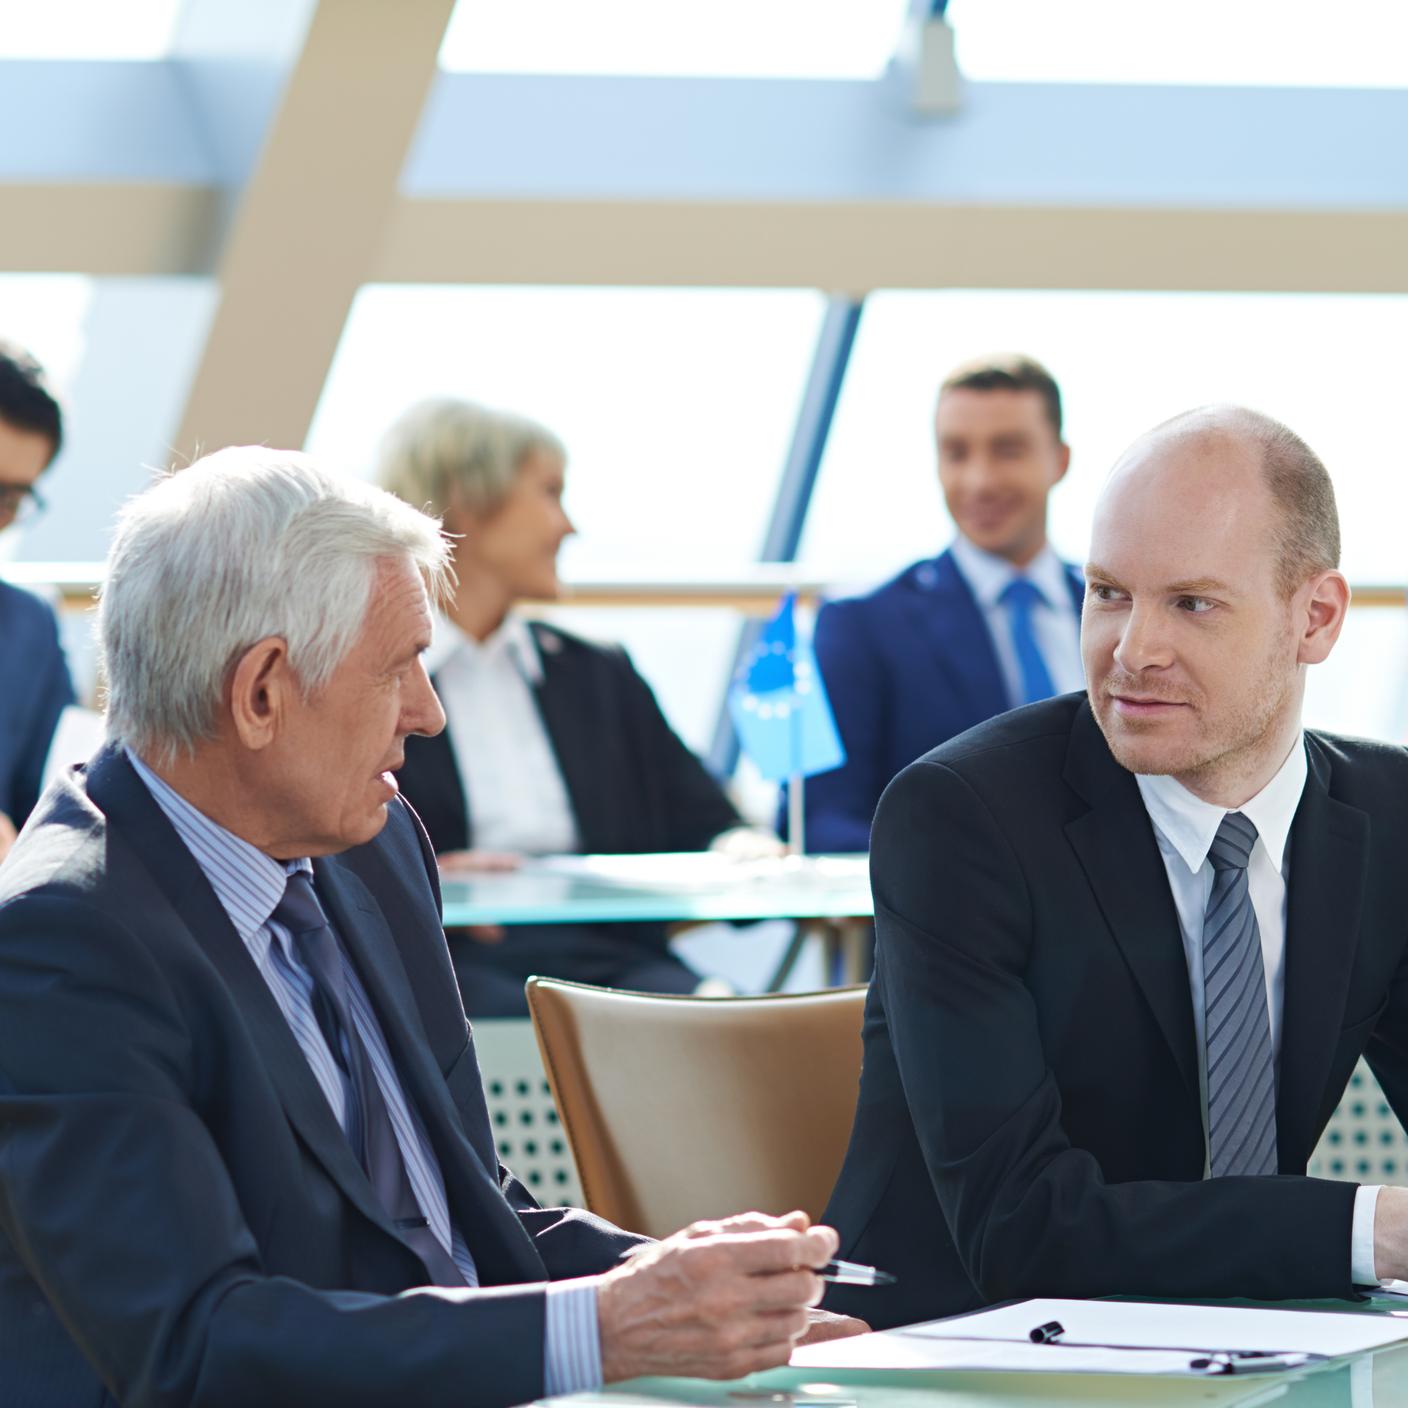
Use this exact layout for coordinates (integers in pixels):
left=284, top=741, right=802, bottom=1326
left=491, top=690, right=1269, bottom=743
left=89, top=749, right=396, bottom=1236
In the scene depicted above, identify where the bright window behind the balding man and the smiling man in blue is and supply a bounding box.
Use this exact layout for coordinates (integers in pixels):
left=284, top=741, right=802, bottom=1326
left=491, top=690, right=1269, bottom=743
left=803, top=291, right=1408, bottom=736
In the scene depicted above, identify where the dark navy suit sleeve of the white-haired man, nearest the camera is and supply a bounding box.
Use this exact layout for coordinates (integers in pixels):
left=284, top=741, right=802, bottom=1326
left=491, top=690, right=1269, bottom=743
left=0, top=894, right=560, bottom=1408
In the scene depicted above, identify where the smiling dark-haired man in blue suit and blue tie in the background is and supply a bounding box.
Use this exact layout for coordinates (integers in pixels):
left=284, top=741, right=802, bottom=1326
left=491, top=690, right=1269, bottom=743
left=807, top=355, right=1084, bottom=850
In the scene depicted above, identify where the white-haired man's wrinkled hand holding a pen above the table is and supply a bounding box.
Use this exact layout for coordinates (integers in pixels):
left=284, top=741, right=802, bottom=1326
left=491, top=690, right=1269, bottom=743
left=597, top=1212, right=839, bottom=1383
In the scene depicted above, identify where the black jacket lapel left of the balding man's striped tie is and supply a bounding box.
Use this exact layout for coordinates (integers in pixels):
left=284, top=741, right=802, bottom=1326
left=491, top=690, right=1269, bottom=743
left=1066, top=703, right=1202, bottom=1118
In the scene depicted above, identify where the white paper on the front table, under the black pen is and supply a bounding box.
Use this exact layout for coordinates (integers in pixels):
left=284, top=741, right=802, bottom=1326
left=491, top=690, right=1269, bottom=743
left=793, top=1300, right=1408, bottom=1374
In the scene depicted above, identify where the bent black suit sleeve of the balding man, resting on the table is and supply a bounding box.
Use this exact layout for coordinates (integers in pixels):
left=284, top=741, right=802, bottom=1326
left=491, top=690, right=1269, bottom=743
left=872, top=762, right=1354, bottom=1301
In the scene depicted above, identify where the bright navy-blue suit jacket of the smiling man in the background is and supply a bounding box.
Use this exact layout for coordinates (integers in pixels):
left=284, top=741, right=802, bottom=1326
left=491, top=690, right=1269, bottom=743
left=807, top=552, right=1086, bottom=850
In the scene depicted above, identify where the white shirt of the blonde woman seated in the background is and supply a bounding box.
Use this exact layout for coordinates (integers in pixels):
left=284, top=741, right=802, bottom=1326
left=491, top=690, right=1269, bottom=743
left=427, top=615, right=580, bottom=856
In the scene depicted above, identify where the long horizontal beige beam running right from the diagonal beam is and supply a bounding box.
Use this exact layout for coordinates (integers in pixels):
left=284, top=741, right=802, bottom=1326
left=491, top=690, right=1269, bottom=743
left=370, top=200, right=1408, bottom=297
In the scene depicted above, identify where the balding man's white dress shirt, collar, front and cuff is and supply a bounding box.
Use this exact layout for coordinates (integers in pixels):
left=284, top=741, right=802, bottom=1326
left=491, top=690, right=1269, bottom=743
left=1135, top=735, right=1378, bottom=1286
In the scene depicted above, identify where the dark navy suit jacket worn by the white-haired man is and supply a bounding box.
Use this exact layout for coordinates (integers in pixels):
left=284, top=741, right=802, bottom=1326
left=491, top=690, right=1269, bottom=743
left=0, top=749, right=638, bottom=1408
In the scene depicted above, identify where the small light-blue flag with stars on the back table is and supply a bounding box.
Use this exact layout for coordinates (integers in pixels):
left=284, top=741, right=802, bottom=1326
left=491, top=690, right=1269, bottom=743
left=728, top=593, right=846, bottom=781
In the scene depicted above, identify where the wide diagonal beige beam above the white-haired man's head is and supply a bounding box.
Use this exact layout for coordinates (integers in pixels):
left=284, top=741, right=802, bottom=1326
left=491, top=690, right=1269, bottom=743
left=175, top=0, right=453, bottom=459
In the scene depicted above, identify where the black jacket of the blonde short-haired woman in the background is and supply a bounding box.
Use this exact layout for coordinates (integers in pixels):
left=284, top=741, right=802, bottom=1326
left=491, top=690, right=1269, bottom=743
left=398, top=621, right=739, bottom=855
